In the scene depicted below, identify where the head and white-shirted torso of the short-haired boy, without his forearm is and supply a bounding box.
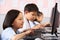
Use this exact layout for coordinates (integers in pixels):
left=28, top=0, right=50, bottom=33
left=19, top=3, right=40, bottom=31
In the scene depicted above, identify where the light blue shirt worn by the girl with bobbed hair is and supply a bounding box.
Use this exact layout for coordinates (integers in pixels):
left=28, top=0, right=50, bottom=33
left=1, top=27, right=16, bottom=40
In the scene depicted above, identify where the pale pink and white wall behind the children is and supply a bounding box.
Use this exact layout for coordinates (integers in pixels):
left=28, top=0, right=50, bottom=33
left=0, top=0, right=56, bottom=17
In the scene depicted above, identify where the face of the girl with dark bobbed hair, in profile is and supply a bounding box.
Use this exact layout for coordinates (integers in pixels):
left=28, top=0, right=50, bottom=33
left=12, top=13, right=23, bottom=29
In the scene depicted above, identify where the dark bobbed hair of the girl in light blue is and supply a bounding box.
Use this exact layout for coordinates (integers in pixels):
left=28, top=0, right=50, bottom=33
left=3, top=9, right=20, bottom=29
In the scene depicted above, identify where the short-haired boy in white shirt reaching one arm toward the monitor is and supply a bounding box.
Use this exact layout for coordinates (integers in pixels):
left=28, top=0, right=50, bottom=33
left=23, top=4, right=43, bottom=40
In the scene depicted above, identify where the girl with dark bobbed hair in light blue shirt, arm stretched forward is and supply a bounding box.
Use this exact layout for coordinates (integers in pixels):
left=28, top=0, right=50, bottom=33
left=1, top=9, right=32, bottom=40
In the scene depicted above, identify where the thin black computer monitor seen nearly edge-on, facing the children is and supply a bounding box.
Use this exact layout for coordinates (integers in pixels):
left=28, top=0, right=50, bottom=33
left=50, top=3, right=59, bottom=36
